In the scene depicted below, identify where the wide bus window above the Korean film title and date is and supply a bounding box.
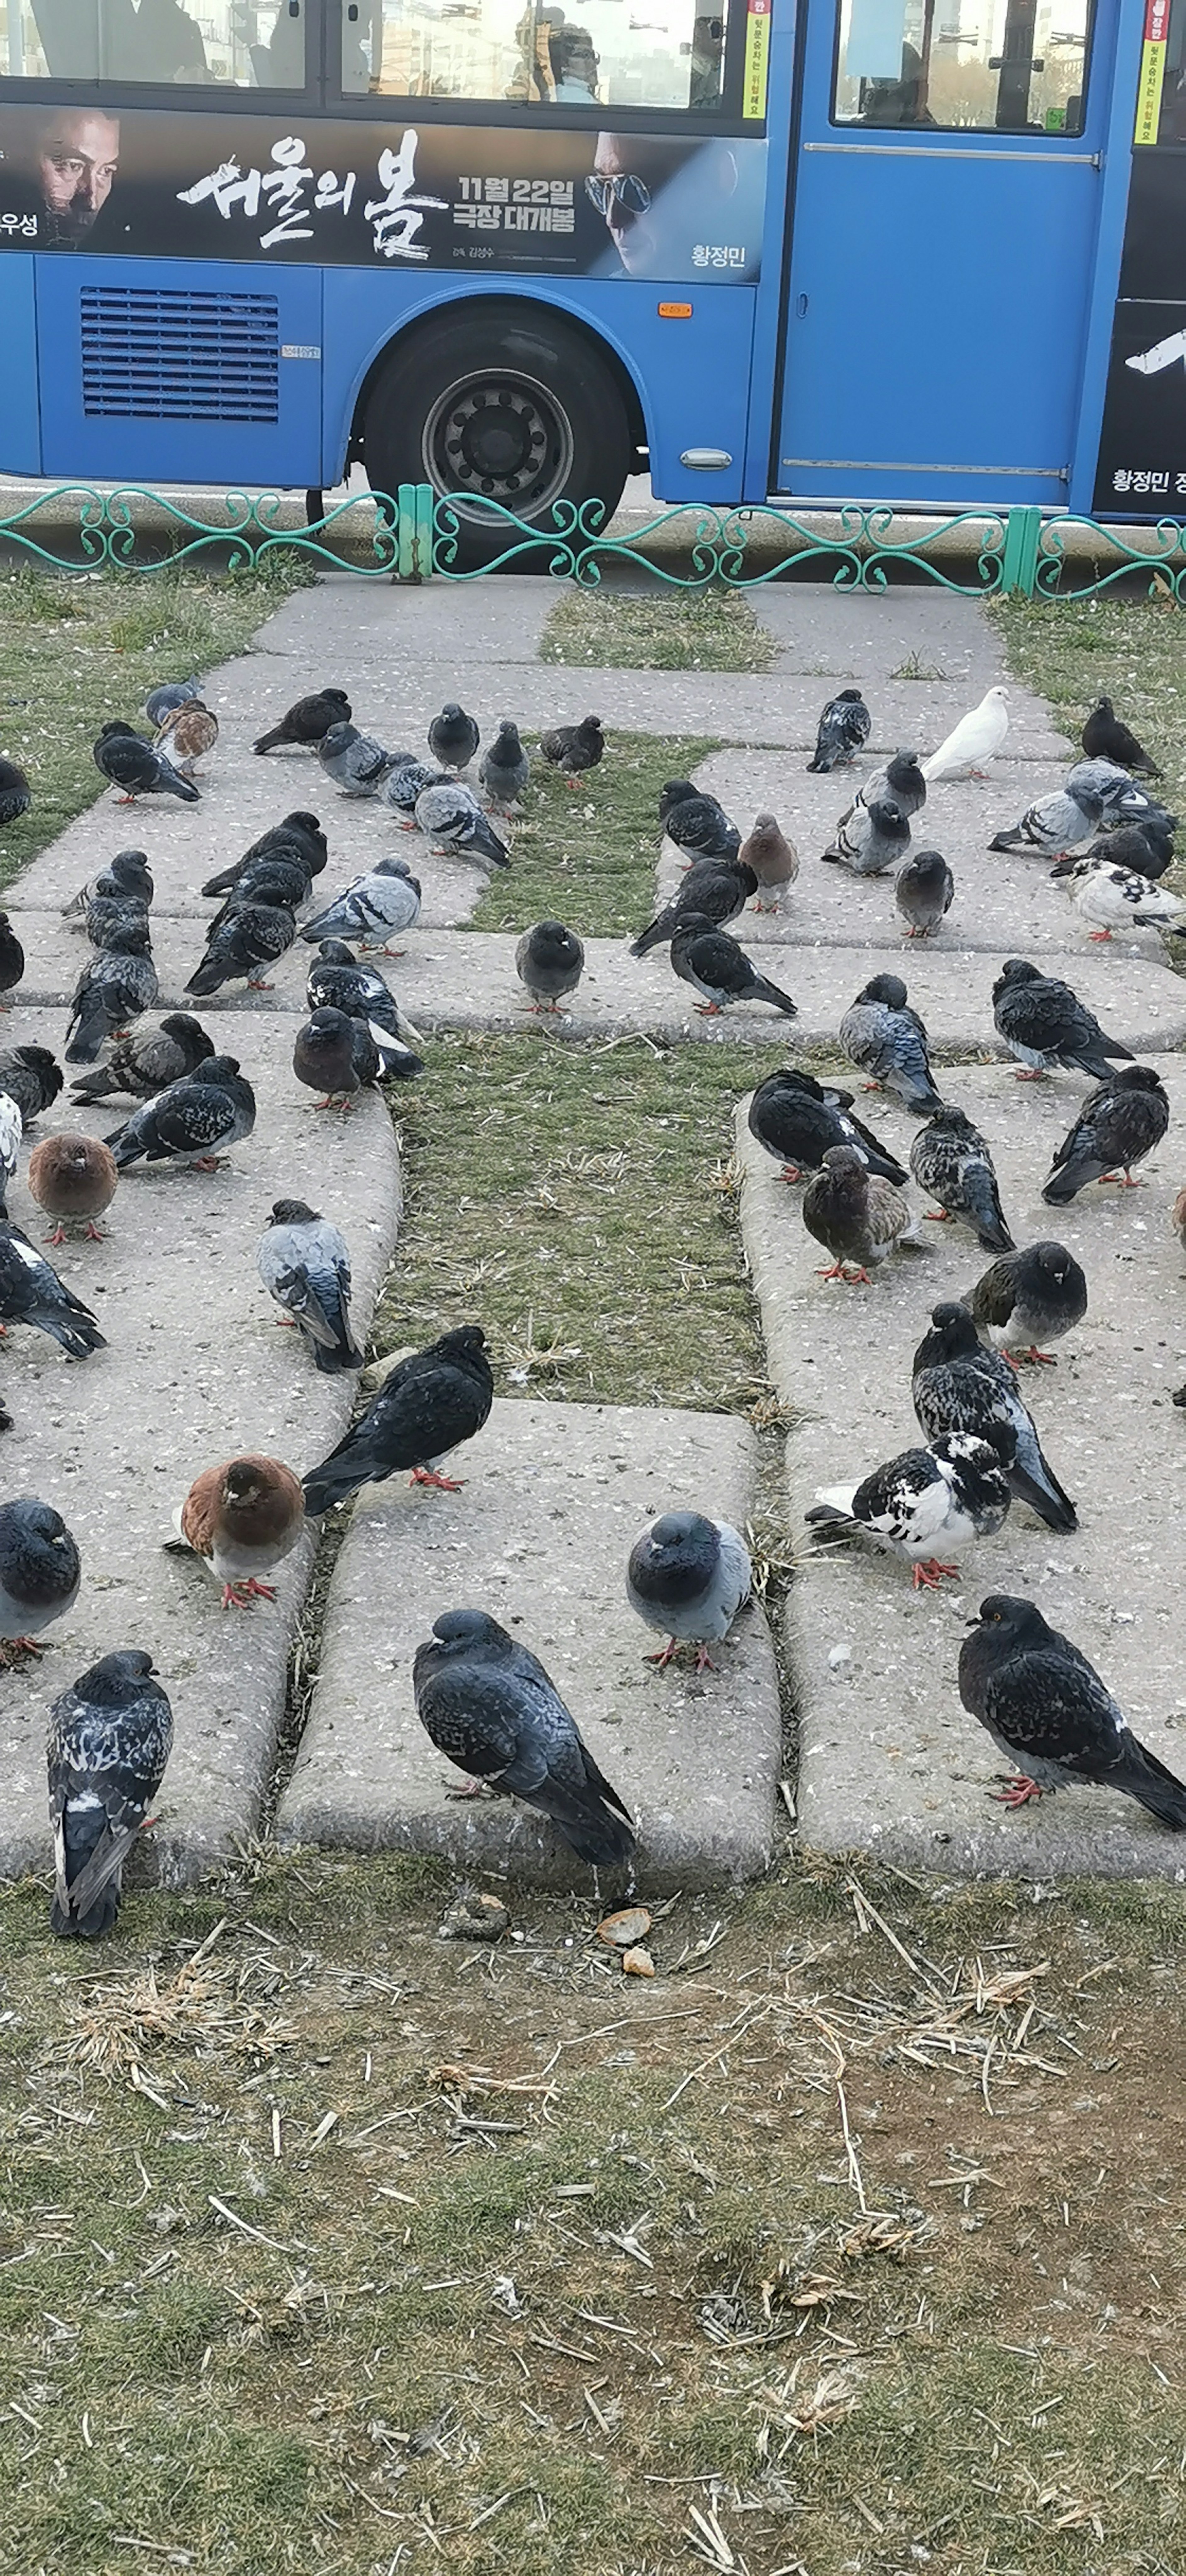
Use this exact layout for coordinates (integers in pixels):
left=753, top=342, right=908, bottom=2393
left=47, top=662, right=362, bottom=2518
left=342, top=0, right=725, bottom=111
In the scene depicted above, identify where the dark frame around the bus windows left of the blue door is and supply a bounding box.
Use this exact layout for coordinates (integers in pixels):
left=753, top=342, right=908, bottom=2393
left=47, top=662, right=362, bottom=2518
left=0, top=0, right=756, bottom=142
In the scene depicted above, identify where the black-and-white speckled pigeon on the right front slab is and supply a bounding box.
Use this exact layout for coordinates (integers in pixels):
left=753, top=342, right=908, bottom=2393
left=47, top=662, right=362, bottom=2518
left=805, top=1432, right=1011, bottom=1592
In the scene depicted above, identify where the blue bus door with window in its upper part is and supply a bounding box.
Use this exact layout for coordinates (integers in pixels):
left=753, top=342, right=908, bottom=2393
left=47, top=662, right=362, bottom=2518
left=774, top=0, right=1117, bottom=508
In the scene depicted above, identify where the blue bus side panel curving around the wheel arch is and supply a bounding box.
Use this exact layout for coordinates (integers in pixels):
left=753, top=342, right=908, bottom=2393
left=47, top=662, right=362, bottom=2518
left=322, top=268, right=756, bottom=505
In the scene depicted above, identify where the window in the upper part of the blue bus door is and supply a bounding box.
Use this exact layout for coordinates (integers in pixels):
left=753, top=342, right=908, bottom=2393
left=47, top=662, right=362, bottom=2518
left=831, top=0, right=1091, bottom=134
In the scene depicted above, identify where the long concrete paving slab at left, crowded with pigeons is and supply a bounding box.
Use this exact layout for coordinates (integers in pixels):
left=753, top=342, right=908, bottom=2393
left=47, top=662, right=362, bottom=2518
left=0, top=1010, right=399, bottom=1886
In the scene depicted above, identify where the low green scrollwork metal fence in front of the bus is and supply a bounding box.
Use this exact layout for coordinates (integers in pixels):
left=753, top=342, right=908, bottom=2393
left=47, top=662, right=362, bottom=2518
left=0, top=484, right=1186, bottom=603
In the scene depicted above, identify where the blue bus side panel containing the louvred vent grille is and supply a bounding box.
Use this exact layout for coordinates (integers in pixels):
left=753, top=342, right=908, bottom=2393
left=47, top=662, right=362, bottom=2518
left=35, top=253, right=322, bottom=487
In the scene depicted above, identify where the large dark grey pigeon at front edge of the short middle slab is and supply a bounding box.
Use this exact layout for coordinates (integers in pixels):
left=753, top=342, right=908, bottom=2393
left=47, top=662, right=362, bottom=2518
left=412, top=1610, right=636, bottom=1870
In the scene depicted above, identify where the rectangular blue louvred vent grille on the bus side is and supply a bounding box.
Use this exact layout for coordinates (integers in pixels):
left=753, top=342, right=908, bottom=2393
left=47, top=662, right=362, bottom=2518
left=80, top=286, right=280, bottom=420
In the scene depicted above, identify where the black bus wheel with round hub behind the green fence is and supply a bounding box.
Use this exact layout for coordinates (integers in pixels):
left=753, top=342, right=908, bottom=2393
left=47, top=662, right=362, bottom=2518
left=363, top=299, right=633, bottom=569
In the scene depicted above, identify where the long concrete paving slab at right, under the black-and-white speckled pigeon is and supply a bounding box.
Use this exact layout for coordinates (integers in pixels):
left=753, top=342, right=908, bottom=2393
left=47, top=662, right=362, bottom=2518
left=738, top=1056, right=1186, bottom=1878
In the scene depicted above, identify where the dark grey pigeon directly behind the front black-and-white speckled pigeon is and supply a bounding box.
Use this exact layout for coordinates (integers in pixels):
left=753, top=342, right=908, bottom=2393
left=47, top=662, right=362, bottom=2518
left=913, top=1298, right=1078, bottom=1530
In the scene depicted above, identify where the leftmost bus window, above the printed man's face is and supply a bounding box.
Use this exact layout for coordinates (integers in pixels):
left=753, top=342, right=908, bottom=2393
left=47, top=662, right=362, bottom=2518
left=0, top=0, right=304, bottom=90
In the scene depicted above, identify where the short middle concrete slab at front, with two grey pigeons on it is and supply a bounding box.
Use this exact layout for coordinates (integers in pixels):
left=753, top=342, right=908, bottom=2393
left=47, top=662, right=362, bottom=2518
left=278, top=1401, right=782, bottom=1896
